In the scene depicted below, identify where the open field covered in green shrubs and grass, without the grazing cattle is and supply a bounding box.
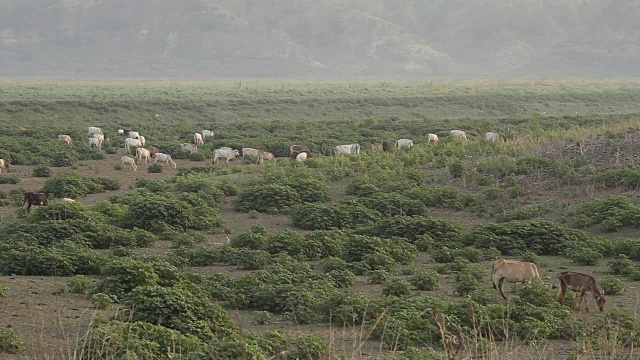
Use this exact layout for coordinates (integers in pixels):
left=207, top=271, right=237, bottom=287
left=0, top=79, right=640, bottom=359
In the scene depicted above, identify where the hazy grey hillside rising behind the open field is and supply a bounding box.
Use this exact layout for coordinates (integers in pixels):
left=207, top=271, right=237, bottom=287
left=0, top=0, right=640, bottom=77
